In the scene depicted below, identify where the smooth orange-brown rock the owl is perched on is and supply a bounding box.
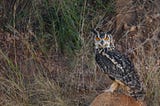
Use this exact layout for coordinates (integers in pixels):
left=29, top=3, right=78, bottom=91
left=90, top=93, right=146, bottom=106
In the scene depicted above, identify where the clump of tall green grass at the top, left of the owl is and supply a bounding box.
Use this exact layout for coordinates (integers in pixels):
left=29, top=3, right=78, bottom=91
left=30, top=0, right=82, bottom=55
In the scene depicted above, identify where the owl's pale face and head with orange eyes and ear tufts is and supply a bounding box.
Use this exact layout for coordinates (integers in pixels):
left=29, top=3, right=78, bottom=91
left=92, top=29, right=114, bottom=50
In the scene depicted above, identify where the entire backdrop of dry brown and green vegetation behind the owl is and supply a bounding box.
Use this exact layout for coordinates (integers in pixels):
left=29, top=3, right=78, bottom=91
left=0, top=0, right=160, bottom=106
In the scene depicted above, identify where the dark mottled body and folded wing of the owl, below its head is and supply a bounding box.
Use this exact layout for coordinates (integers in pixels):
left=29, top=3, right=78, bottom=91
left=95, top=48, right=146, bottom=100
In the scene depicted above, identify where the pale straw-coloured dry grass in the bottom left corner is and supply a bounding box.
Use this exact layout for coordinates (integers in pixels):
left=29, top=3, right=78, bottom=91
left=0, top=48, right=67, bottom=106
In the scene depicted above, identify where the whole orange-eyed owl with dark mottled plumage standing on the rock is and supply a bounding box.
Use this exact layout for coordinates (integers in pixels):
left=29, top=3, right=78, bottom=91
left=92, top=29, right=145, bottom=100
